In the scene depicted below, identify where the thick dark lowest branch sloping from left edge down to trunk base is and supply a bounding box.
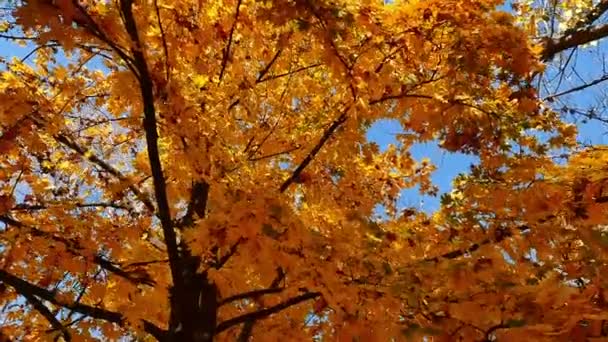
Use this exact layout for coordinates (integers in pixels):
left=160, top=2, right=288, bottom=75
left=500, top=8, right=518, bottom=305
left=0, top=269, right=165, bottom=340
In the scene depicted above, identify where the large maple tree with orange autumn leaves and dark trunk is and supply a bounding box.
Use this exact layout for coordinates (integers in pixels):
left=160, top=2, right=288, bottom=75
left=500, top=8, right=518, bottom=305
left=0, top=0, right=603, bottom=341
